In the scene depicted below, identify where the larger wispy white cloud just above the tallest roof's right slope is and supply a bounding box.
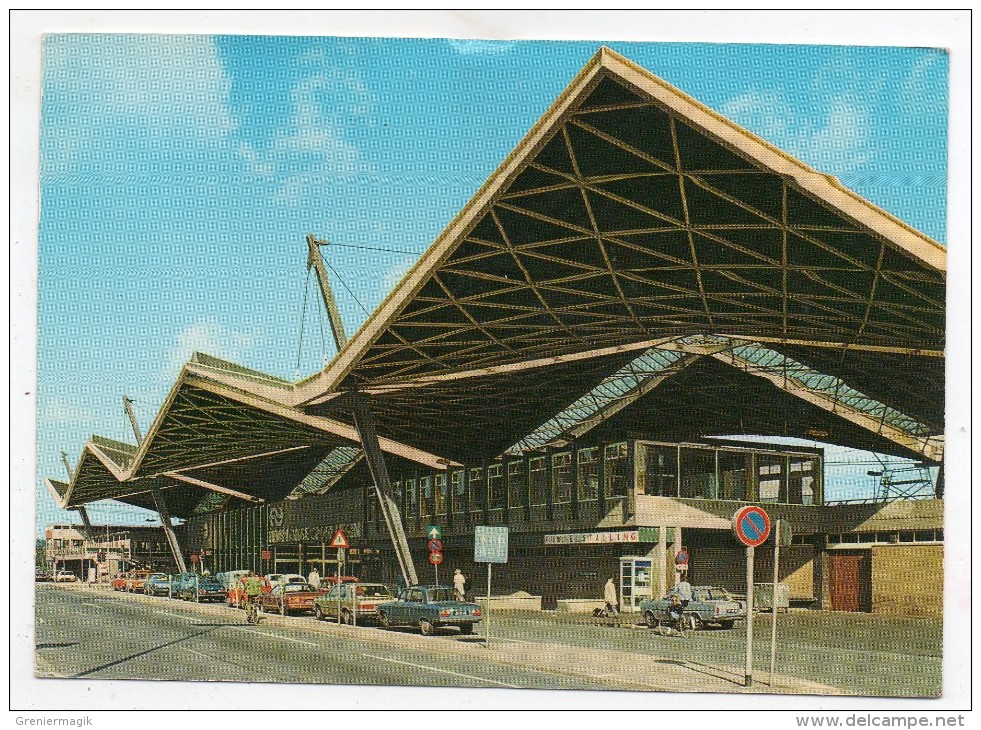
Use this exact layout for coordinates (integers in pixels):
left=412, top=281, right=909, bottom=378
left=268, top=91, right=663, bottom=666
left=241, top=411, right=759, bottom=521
left=722, top=89, right=871, bottom=175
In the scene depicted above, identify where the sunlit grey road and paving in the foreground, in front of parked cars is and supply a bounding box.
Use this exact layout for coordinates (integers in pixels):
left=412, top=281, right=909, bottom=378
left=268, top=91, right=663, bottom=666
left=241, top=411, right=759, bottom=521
left=35, top=584, right=942, bottom=697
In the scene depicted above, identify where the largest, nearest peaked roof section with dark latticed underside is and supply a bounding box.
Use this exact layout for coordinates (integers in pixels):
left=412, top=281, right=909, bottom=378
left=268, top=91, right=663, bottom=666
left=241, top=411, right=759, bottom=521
left=294, top=48, right=946, bottom=404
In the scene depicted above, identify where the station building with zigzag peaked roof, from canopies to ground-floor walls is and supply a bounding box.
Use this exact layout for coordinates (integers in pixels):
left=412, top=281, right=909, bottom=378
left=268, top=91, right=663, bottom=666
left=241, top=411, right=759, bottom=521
left=48, top=49, right=946, bottom=615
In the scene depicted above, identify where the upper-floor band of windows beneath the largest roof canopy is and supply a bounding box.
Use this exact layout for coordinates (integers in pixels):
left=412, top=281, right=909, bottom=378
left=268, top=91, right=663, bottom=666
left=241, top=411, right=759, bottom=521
left=386, top=441, right=823, bottom=521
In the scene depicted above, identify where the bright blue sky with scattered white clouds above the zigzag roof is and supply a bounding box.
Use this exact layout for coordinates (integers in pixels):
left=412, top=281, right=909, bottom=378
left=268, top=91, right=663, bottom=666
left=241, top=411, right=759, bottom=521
left=37, top=35, right=948, bottom=525
